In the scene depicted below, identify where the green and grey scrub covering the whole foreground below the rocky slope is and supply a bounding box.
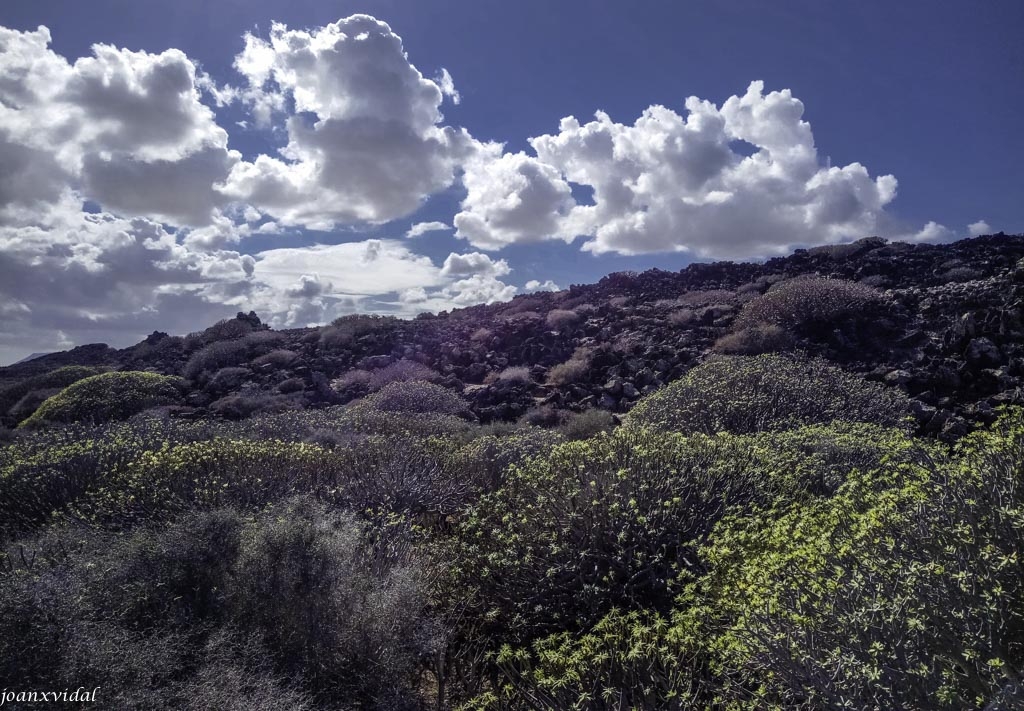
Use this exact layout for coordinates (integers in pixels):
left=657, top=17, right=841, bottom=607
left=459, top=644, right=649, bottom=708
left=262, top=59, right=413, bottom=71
left=0, top=336, right=1024, bottom=711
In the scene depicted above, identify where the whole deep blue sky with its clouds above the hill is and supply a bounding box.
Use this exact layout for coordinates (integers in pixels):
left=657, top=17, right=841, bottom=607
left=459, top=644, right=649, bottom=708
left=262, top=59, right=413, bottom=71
left=0, top=0, right=1024, bottom=363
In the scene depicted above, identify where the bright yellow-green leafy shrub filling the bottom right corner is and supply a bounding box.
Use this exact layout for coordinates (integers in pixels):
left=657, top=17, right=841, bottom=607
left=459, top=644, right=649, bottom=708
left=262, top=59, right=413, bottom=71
left=677, top=412, right=1024, bottom=710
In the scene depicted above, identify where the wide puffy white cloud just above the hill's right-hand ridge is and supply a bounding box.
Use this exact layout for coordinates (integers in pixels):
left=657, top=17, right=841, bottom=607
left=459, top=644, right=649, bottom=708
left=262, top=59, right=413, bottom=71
left=456, top=82, right=896, bottom=257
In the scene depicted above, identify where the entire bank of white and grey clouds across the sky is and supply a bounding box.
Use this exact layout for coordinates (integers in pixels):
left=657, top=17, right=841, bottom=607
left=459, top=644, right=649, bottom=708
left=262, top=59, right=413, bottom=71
left=0, top=15, right=966, bottom=359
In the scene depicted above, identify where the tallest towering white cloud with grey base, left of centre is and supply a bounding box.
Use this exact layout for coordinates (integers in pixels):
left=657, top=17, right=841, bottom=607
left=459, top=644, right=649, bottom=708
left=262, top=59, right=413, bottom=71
left=224, top=15, right=478, bottom=228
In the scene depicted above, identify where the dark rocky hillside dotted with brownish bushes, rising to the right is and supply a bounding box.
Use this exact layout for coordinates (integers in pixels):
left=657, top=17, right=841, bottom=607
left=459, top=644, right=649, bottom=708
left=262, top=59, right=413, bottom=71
left=0, top=234, right=1024, bottom=438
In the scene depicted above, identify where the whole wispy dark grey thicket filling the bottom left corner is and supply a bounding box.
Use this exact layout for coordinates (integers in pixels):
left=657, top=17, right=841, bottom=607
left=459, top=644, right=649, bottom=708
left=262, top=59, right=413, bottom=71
left=0, top=499, right=438, bottom=711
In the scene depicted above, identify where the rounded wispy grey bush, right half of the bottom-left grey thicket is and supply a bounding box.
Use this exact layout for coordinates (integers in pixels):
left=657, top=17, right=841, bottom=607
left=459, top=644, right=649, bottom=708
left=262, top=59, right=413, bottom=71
left=229, top=499, right=437, bottom=711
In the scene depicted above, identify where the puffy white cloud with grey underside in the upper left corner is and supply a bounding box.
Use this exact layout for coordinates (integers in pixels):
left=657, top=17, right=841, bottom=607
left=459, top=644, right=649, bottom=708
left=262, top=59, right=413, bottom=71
left=0, top=27, right=238, bottom=224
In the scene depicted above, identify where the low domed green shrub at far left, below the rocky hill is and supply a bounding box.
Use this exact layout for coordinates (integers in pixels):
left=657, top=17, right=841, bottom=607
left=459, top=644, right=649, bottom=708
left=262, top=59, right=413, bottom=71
left=20, top=371, right=181, bottom=427
